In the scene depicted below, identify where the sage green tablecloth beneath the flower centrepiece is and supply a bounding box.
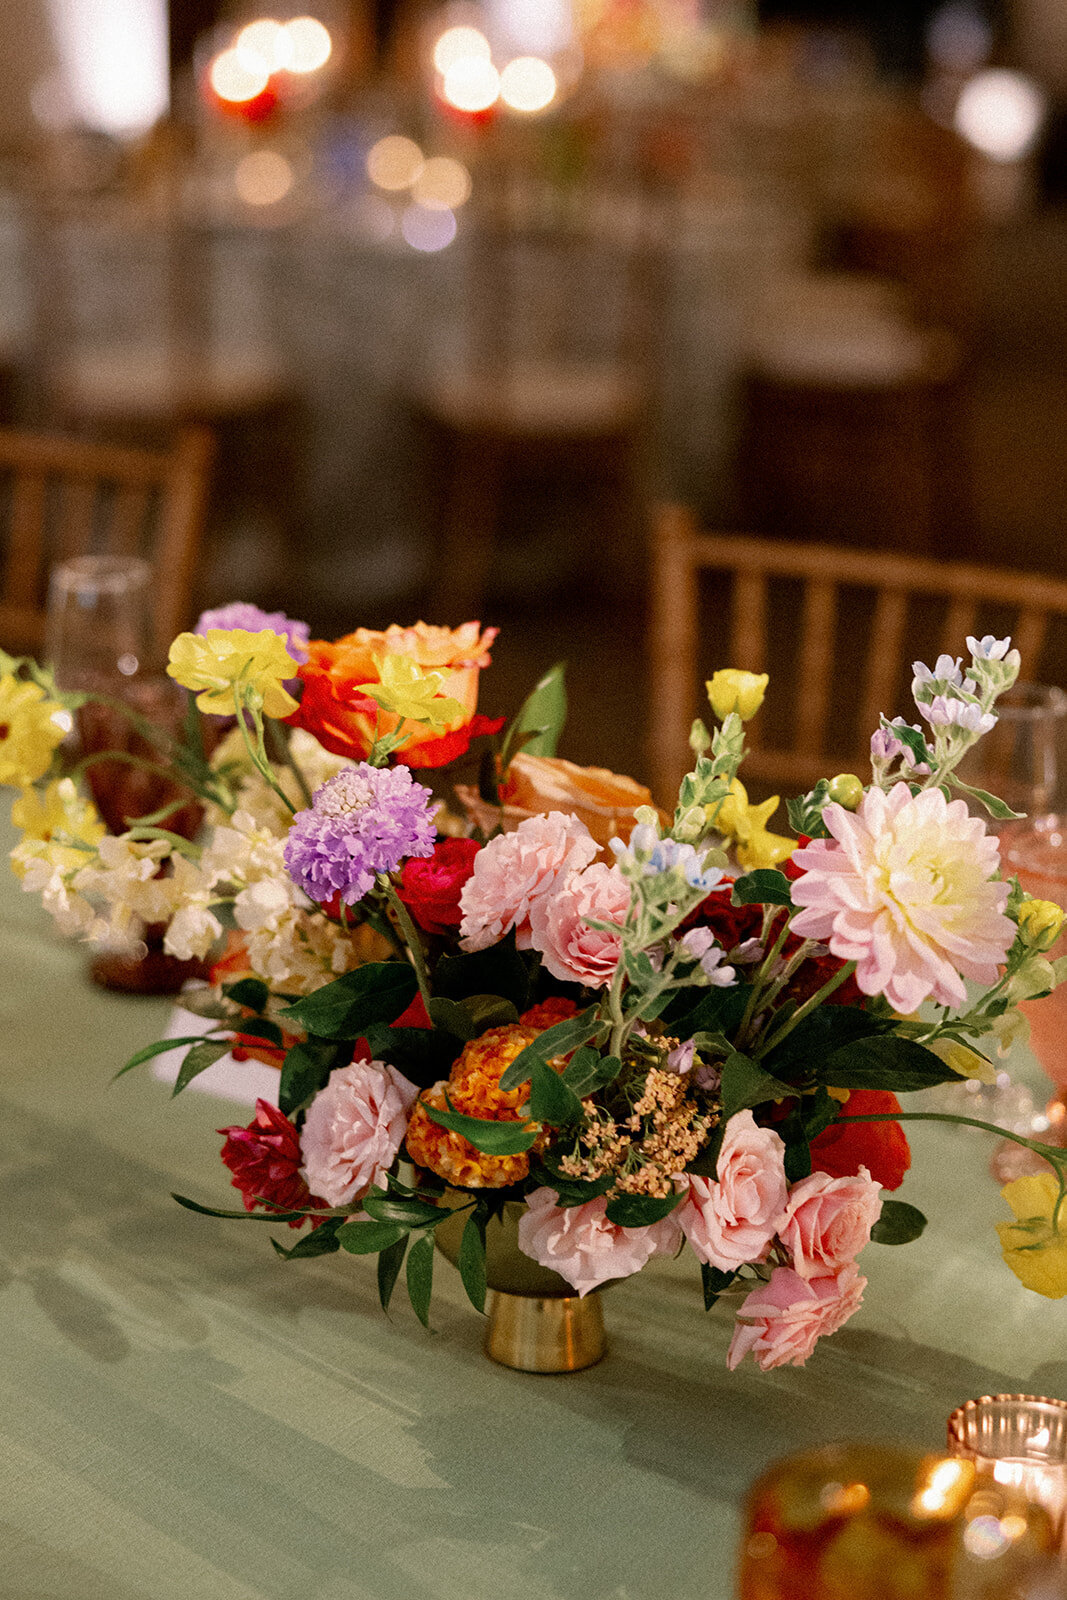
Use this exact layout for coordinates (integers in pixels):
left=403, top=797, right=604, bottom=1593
left=0, top=838, right=1067, bottom=1600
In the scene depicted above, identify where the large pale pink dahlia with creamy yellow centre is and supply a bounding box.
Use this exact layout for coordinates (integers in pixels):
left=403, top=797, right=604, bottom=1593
left=793, top=784, right=1016, bottom=1011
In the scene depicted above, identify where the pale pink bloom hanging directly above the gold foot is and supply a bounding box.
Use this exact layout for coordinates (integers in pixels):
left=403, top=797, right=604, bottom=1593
left=518, top=1189, right=678, bottom=1294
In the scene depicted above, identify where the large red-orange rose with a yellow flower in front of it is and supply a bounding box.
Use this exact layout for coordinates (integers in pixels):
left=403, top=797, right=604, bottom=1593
left=286, top=622, right=502, bottom=766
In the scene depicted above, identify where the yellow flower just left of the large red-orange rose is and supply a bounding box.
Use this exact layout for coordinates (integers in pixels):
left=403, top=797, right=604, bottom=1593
left=166, top=627, right=298, bottom=717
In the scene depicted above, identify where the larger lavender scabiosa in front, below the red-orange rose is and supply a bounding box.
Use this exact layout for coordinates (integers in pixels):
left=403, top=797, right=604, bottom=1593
left=285, top=762, right=437, bottom=906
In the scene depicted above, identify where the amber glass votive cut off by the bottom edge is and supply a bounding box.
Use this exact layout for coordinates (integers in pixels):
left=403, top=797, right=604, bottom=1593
left=737, top=1443, right=1056, bottom=1600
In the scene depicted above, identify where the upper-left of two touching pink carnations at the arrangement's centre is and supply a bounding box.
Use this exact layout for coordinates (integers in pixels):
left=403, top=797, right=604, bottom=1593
left=459, top=811, right=598, bottom=950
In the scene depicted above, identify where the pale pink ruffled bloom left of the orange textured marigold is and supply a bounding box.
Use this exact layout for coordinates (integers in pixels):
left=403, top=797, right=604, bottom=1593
left=301, top=1061, right=419, bottom=1205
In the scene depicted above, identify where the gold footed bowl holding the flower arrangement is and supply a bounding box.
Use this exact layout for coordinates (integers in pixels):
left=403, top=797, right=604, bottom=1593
left=435, top=1192, right=608, bottom=1373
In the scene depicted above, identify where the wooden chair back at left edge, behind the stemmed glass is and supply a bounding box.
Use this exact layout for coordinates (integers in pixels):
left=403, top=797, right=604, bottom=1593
left=0, top=427, right=214, bottom=651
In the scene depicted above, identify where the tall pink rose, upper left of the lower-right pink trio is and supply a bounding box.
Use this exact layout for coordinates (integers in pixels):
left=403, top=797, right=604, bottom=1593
left=677, top=1110, right=789, bottom=1272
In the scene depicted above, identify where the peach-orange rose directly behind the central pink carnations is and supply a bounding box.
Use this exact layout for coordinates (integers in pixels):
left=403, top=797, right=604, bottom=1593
left=456, top=750, right=653, bottom=845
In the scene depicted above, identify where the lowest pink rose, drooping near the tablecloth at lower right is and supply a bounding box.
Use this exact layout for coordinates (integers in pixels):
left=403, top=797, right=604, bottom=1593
left=726, top=1264, right=867, bottom=1373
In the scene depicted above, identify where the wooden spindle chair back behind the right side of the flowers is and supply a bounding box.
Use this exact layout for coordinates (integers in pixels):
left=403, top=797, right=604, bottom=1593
left=651, top=506, right=1067, bottom=800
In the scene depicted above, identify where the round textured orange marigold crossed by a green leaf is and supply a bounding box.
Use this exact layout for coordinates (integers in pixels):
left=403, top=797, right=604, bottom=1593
left=406, top=1022, right=541, bottom=1189
